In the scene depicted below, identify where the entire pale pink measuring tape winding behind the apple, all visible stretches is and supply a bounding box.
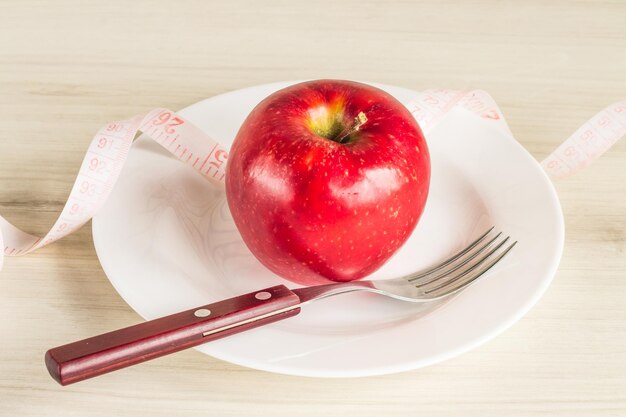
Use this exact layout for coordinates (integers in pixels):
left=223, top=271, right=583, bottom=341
left=0, top=90, right=626, bottom=270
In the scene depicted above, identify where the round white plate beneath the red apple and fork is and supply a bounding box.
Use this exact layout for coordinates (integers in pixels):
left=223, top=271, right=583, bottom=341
left=93, top=83, right=564, bottom=377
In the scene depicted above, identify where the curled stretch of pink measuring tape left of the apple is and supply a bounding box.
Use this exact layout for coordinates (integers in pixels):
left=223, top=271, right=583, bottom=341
left=0, top=108, right=228, bottom=269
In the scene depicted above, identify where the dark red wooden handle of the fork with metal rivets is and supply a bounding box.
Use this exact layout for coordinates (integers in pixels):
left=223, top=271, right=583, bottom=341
left=45, top=285, right=300, bottom=385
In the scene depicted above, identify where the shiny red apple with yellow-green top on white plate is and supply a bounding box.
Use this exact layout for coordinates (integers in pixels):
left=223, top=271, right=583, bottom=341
left=226, top=80, right=430, bottom=285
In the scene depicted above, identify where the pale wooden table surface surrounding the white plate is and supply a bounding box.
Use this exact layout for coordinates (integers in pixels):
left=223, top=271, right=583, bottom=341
left=0, top=0, right=626, bottom=417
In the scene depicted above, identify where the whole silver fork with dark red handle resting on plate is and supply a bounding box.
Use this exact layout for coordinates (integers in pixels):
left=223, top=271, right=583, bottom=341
left=45, top=227, right=517, bottom=385
